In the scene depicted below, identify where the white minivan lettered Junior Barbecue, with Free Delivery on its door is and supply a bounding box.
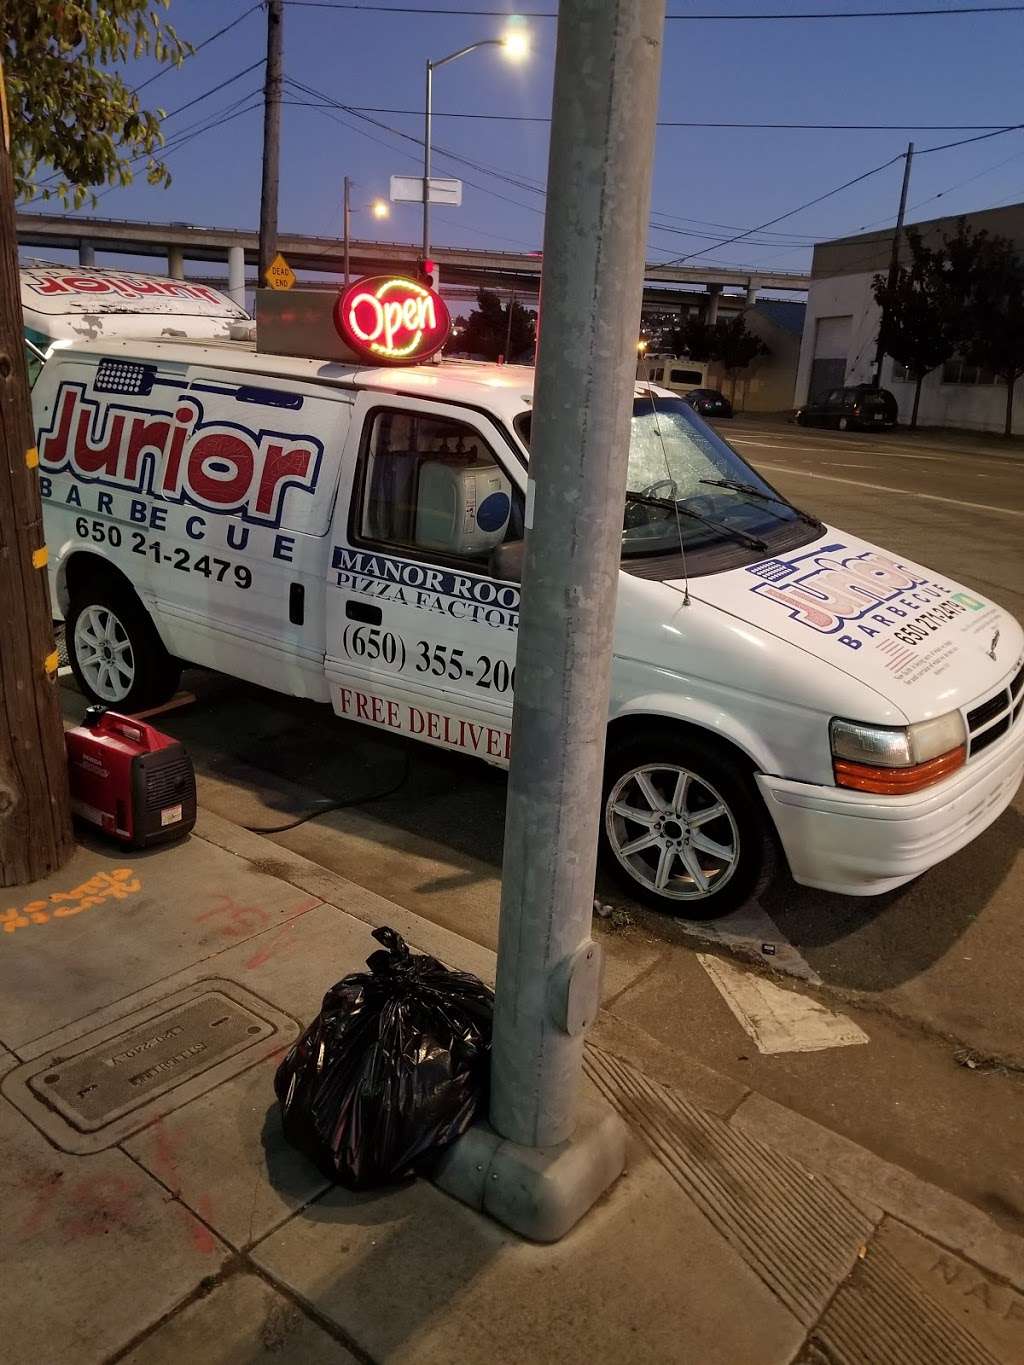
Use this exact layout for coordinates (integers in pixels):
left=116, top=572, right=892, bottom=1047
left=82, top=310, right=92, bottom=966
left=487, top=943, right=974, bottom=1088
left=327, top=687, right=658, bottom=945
left=34, top=281, right=1024, bottom=917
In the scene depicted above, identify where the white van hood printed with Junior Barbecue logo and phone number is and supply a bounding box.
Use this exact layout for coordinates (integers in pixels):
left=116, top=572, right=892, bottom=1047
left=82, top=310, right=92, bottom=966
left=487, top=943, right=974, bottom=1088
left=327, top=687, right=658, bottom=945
left=669, top=527, right=1024, bottom=721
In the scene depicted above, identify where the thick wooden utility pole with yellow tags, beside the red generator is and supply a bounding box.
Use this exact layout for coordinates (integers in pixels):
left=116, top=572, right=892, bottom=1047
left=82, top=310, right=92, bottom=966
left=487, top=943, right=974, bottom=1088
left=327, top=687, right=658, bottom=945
left=0, top=67, right=75, bottom=887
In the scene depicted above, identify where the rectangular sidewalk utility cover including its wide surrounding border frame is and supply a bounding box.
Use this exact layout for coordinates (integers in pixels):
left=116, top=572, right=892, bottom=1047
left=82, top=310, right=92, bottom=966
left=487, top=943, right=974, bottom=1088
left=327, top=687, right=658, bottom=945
left=0, top=977, right=299, bottom=1156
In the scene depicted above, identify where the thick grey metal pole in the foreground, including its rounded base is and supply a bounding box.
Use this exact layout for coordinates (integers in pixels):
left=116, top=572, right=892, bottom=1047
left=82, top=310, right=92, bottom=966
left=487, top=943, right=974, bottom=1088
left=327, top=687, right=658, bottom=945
left=441, top=0, right=665, bottom=1241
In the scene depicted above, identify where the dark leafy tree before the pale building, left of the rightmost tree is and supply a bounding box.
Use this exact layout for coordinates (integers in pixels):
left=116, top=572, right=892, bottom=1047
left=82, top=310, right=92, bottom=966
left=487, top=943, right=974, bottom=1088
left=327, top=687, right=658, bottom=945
left=871, top=222, right=978, bottom=430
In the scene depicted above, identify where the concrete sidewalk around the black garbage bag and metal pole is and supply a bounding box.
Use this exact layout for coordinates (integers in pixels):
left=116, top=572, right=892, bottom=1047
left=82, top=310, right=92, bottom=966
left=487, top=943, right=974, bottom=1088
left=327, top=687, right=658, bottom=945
left=0, top=814, right=1024, bottom=1365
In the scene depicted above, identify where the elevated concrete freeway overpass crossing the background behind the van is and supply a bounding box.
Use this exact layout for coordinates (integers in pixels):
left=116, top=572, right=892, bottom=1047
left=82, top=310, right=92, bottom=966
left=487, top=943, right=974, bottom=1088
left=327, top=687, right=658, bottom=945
left=18, top=212, right=810, bottom=317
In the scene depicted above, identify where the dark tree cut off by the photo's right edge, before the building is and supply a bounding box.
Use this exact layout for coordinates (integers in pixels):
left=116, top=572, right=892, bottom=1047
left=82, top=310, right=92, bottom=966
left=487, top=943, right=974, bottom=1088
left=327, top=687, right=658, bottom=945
left=961, top=238, right=1024, bottom=435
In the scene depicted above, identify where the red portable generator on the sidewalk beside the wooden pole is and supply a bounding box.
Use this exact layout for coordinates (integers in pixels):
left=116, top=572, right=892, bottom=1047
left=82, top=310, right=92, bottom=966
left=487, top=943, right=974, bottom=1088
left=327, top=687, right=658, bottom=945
left=64, top=706, right=195, bottom=849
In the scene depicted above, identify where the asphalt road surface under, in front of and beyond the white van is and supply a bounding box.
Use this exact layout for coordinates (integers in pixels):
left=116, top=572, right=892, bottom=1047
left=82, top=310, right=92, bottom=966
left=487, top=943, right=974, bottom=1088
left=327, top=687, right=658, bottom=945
left=58, top=418, right=1024, bottom=1231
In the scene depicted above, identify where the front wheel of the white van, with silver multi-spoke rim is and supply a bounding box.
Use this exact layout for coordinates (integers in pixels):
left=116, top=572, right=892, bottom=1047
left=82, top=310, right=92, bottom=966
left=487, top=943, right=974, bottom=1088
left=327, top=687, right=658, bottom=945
left=601, top=729, right=773, bottom=920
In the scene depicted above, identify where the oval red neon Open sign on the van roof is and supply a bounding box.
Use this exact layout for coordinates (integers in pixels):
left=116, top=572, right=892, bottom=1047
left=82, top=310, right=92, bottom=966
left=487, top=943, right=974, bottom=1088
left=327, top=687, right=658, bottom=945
left=335, top=274, right=452, bottom=364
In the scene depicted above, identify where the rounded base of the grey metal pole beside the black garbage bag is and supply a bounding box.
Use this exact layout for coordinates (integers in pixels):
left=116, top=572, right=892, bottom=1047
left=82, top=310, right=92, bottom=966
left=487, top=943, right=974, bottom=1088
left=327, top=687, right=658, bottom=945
left=434, top=1099, right=627, bottom=1242
